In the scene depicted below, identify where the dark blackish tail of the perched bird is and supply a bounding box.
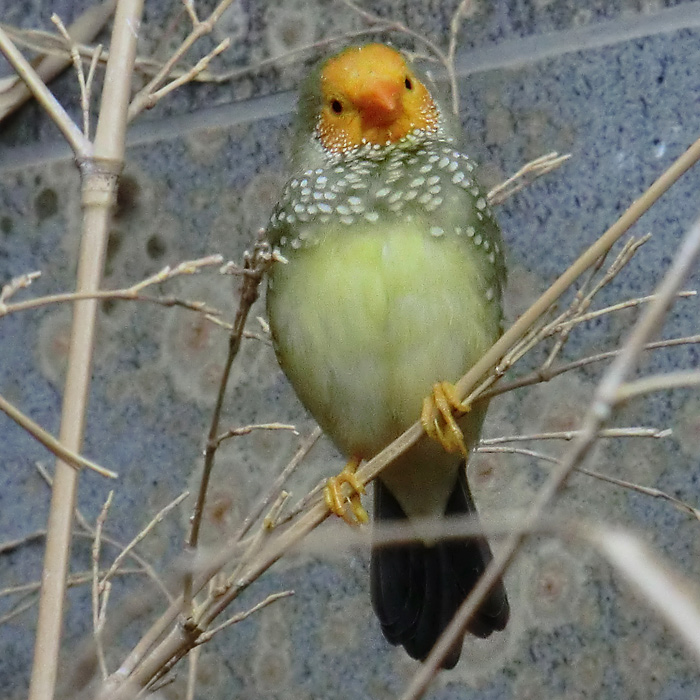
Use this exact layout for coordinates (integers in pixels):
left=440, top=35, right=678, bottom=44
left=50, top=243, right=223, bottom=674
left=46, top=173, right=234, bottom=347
left=370, top=465, right=510, bottom=668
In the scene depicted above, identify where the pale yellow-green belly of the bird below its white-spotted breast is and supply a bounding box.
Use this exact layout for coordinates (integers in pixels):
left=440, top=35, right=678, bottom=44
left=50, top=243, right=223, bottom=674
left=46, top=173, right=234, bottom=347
left=268, top=221, right=500, bottom=458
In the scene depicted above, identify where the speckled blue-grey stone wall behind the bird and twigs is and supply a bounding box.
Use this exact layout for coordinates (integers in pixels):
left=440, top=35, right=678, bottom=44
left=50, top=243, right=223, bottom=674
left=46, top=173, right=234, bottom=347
left=0, top=0, right=700, bottom=700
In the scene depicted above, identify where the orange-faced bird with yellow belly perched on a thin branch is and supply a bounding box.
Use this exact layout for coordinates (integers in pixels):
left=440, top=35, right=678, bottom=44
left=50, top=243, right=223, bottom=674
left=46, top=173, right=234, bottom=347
left=266, top=43, right=510, bottom=668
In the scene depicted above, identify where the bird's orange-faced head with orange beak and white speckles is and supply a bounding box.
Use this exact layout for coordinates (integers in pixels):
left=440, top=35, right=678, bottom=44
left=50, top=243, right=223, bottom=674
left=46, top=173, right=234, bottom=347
left=292, top=44, right=452, bottom=167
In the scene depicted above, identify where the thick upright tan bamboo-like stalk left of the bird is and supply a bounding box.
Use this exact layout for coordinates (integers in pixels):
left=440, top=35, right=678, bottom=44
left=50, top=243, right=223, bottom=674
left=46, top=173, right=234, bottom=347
left=29, top=0, right=143, bottom=700
